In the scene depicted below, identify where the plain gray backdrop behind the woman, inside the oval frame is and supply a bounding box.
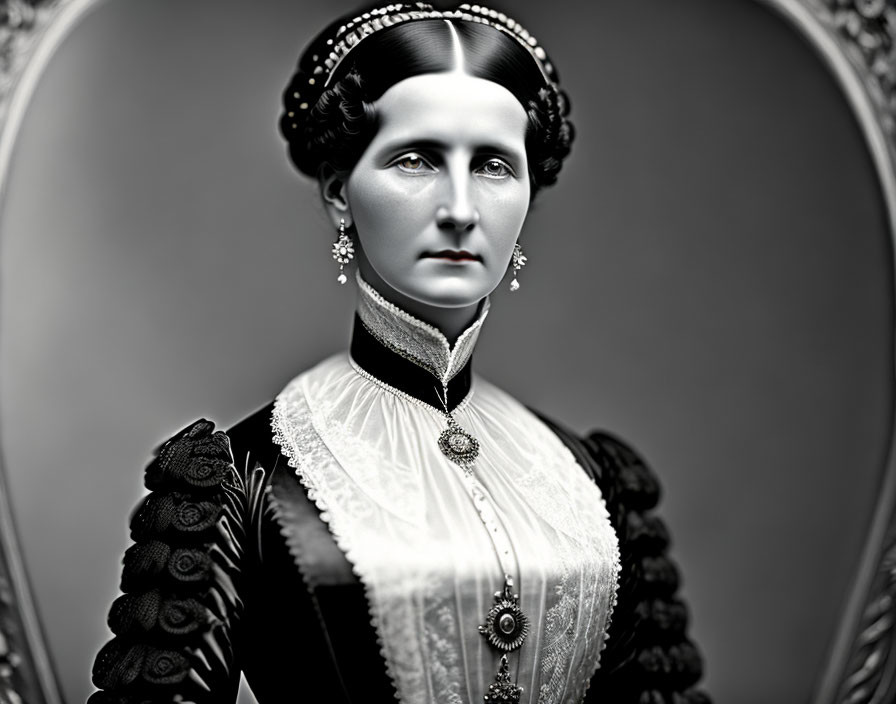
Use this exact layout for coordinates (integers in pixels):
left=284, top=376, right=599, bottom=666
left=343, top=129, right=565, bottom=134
left=0, top=0, right=893, bottom=704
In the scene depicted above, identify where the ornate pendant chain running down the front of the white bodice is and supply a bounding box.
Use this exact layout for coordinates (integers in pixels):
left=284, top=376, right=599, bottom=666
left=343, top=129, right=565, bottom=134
left=438, top=386, right=529, bottom=704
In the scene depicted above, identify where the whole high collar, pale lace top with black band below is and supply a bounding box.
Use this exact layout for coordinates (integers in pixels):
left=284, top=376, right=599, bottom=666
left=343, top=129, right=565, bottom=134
left=351, top=274, right=489, bottom=411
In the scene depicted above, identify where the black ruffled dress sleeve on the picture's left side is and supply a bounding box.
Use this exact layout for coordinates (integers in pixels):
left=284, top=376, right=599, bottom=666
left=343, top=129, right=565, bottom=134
left=88, top=420, right=246, bottom=704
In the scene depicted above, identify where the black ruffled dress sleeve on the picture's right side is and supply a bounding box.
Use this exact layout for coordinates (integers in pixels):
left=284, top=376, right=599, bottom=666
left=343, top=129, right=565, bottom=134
left=584, top=433, right=710, bottom=704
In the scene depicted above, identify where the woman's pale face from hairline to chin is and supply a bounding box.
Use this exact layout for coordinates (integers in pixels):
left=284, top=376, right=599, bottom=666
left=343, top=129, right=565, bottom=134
left=345, top=71, right=530, bottom=308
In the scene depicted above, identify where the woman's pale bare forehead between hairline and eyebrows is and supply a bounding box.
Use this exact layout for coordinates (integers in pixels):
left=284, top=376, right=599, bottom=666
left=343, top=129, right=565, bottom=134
left=376, top=71, right=528, bottom=148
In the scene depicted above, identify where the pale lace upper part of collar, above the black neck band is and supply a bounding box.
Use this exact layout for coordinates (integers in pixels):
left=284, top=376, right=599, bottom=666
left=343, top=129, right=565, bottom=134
left=353, top=273, right=489, bottom=387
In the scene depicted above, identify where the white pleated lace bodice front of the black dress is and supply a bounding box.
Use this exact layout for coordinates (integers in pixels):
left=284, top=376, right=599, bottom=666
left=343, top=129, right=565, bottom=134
left=273, top=278, right=619, bottom=704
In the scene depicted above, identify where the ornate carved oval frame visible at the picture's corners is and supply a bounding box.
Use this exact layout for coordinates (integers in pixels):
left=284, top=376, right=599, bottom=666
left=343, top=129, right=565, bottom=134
left=0, top=0, right=896, bottom=704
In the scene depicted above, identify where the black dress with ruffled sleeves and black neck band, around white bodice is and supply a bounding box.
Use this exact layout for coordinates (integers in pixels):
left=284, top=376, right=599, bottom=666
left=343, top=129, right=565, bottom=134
left=89, top=310, right=709, bottom=704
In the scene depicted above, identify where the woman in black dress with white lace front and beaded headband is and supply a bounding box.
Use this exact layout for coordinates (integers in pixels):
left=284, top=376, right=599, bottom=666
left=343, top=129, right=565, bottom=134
left=91, top=5, right=708, bottom=704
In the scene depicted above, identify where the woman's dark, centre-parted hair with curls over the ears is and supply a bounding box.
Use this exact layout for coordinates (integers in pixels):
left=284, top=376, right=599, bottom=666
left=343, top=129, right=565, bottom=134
left=280, top=13, right=574, bottom=196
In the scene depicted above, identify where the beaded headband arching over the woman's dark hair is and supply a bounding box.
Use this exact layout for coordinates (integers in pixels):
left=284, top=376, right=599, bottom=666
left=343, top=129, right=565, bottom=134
left=289, top=2, right=557, bottom=122
